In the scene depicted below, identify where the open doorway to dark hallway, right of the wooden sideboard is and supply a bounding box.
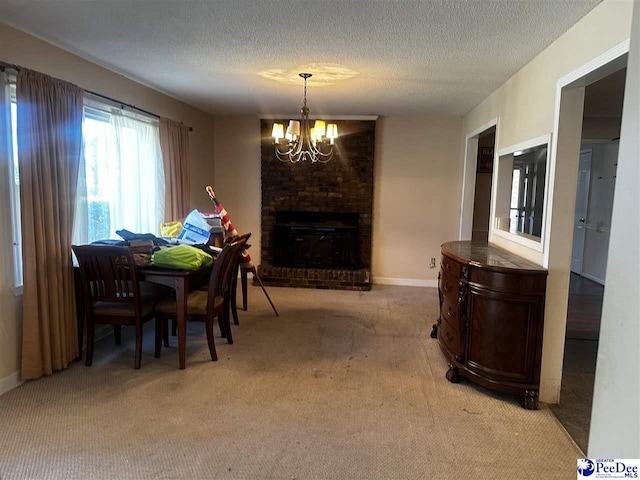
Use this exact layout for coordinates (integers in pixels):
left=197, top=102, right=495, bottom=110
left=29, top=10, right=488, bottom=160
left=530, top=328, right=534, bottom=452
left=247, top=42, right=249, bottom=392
left=551, top=67, right=626, bottom=453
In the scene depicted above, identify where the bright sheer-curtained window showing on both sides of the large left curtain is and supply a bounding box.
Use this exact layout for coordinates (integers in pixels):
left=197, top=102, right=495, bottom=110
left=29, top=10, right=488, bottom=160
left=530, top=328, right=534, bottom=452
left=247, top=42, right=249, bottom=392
left=0, top=86, right=164, bottom=287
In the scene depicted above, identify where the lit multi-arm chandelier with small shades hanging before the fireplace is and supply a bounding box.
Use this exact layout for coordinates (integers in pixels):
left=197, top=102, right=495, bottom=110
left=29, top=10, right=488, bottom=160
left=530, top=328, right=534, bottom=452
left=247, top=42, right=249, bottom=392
left=271, top=73, right=338, bottom=163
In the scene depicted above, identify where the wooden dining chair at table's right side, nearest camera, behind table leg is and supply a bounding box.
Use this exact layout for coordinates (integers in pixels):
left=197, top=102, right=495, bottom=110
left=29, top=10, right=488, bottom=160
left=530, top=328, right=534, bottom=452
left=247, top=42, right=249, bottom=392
left=155, top=239, right=246, bottom=361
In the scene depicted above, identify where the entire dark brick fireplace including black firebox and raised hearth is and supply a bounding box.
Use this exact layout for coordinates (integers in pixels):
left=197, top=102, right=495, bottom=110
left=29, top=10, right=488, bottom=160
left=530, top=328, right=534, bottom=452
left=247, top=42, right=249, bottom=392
left=258, top=119, right=376, bottom=290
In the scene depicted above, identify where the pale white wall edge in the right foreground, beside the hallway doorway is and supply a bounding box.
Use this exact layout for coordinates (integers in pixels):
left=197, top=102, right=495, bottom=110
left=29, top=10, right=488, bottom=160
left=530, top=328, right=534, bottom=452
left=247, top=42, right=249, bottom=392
left=588, top=2, right=640, bottom=458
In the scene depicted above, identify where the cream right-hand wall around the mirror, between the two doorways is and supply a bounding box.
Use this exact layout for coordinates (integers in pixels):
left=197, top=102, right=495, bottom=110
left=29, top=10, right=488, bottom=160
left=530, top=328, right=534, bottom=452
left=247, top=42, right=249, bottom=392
left=463, top=0, right=633, bottom=403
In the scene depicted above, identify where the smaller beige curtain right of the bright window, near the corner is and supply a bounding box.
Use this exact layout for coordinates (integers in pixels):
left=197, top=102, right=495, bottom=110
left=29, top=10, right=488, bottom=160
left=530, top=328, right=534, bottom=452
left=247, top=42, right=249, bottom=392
left=160, top=118, right=190, bottom=222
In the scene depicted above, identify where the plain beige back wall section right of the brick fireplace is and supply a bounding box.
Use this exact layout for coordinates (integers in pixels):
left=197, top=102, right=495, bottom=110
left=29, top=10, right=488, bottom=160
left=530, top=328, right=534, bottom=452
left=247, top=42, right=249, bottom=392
left=371, top=117, right=462, bottom=286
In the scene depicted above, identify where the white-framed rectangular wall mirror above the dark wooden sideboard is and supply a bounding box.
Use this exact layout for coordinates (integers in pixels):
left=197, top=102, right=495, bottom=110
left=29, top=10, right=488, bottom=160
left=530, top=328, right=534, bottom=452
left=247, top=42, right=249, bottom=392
left=493, top=134, right=551, bottom=251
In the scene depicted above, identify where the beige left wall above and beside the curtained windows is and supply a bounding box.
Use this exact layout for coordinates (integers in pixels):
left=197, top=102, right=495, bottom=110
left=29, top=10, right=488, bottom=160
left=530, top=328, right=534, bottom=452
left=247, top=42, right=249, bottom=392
left=0, top=23, right=213, bottom=394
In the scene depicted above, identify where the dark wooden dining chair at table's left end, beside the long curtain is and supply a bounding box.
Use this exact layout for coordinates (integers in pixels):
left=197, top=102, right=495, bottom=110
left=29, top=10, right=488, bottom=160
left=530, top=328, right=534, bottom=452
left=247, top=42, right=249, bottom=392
left=71, top=245, right=161, bottom=369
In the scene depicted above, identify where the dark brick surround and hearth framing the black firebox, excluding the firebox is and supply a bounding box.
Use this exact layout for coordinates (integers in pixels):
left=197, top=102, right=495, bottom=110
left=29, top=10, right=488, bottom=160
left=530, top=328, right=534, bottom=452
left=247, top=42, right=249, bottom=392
left=258, top=118, right=376, bottom=290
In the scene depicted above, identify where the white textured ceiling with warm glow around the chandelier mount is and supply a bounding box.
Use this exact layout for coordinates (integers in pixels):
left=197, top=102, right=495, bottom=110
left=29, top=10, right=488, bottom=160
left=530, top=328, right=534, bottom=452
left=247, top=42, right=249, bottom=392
left=0, top=0, right=600, bottom=116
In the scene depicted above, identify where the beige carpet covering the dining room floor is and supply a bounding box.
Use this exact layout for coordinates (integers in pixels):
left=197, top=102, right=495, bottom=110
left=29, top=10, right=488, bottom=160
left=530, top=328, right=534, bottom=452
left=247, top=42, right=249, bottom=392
left=0, top=286, right=582, bottom=480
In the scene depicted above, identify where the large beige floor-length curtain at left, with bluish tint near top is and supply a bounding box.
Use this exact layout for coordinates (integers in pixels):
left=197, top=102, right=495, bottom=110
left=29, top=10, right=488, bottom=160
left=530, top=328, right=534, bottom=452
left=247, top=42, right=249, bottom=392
left=16, top=69, right=84, bottom=379
